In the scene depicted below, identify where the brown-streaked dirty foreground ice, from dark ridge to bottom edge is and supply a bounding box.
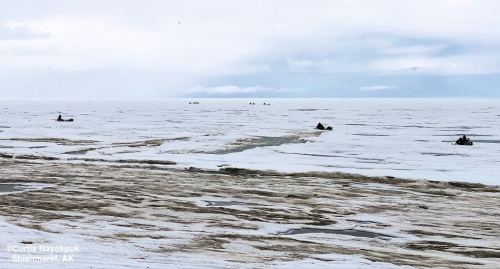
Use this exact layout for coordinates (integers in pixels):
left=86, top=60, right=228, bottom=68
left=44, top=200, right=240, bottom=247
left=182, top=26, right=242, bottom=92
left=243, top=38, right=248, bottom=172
left=0, top=160, right=500, bottom=269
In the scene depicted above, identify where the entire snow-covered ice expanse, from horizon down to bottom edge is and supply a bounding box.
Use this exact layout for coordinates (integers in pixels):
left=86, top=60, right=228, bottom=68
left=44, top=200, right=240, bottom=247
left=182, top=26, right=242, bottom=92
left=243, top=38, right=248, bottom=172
left=0, top=99, right=500, bottom=269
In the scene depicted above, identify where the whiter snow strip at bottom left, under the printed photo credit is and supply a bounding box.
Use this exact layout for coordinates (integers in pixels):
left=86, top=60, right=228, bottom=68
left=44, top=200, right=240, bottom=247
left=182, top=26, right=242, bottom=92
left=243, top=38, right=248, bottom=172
left=0, top=217, right=413, bottom=269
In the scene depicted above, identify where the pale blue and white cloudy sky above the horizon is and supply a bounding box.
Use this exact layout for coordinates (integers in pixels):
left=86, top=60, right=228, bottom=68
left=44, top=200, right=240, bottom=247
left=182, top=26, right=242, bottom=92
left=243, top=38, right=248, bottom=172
left=0, top=0, right=500, bottom=99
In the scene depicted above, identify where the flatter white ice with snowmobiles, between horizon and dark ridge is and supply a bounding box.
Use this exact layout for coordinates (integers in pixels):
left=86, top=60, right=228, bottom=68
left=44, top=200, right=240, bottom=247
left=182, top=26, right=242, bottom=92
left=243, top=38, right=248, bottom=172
left=0, top=99, right=500, bottom=185
